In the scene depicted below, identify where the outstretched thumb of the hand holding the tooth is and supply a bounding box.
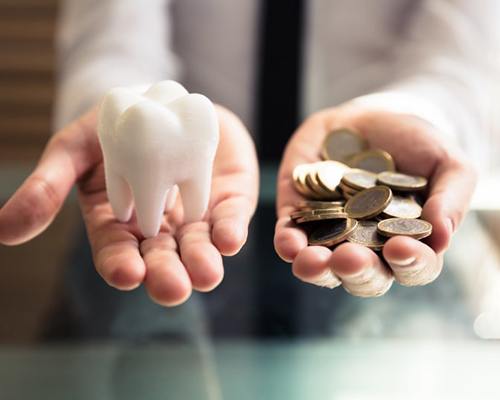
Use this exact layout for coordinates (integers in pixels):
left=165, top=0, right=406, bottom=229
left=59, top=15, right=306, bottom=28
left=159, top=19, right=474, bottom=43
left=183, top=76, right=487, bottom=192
left=0, top=113, right=100, bottom=245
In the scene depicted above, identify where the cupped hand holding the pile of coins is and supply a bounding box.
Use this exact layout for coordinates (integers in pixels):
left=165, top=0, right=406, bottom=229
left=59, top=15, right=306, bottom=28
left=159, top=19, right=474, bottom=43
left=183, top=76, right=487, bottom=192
left=274, top=104, right=476, bottom=297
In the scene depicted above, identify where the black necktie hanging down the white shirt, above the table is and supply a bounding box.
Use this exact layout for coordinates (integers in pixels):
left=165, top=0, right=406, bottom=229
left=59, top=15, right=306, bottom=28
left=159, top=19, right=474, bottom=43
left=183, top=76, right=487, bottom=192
left=256, top=0, right=304, bottom=161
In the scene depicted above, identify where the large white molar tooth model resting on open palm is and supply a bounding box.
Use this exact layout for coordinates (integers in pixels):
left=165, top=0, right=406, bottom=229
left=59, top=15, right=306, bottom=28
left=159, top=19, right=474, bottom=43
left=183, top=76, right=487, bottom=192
left=97, top=81, right=219, bottom=237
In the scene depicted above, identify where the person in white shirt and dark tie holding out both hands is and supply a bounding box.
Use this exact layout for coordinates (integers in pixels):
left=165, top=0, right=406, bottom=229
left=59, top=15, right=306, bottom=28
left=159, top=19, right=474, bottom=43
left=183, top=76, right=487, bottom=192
left=0, top=0, right=500, bottom=306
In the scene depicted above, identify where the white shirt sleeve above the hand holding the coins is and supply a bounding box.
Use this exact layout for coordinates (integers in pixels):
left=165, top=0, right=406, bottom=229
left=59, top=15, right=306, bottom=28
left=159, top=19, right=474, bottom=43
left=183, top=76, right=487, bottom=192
left=354, top=0, right=500, bottom=166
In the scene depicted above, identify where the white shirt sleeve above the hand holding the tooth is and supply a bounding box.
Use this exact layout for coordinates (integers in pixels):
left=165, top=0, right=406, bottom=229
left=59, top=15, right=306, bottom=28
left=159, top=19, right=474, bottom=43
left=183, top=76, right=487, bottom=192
left=54, top=0, right=178, bottom=128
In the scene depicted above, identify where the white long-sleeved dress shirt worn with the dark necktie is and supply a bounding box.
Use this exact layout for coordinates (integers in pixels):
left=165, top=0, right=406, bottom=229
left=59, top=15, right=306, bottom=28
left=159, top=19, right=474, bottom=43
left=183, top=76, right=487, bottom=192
left=55, top=0, right=500, bottom=168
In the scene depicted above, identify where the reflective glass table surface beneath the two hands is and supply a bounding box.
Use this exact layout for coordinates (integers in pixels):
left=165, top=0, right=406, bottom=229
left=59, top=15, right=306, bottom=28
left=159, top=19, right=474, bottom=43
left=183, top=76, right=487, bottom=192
left=0, top=164, right=500, bottom=400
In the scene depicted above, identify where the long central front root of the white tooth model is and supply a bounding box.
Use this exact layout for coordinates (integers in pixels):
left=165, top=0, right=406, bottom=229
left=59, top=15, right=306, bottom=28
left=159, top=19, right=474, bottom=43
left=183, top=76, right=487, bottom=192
left=131, top=179, right=167, bottom=238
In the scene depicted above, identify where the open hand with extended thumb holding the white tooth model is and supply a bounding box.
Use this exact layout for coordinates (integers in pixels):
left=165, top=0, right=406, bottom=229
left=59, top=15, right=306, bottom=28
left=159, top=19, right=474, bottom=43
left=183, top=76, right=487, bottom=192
left=0, top=107, right=258, bottom=306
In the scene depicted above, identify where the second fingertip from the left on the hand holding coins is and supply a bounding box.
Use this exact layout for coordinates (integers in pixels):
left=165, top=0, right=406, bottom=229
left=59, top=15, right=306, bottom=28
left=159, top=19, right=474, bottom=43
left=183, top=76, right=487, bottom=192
left=292, top=246, right=341, bottom=289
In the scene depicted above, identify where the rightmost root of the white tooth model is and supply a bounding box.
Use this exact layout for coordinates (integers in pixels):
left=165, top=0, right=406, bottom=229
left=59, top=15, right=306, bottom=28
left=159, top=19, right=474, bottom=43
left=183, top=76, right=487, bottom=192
left=179, top=167, right=212, bottom=223
